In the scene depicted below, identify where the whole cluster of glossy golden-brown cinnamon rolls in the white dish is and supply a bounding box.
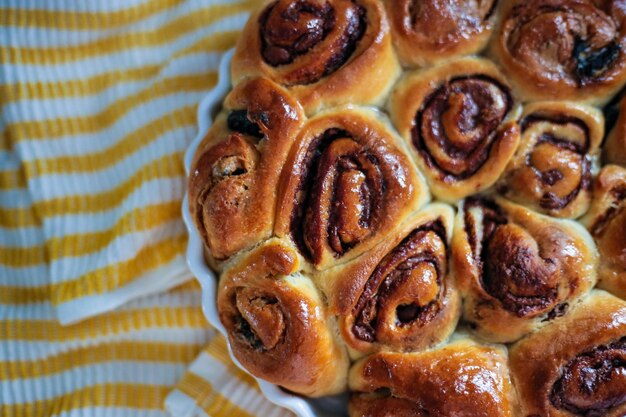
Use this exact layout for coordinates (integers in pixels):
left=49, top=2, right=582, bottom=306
left=189, top=0, right=626, bottom=417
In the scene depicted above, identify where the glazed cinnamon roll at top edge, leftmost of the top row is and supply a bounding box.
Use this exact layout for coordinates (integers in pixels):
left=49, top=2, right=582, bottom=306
left=231, top=0, right=401, bottom=114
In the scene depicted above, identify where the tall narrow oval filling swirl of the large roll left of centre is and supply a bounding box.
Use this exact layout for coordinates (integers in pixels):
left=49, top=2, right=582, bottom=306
left=291, top=128, right=388, bottom=262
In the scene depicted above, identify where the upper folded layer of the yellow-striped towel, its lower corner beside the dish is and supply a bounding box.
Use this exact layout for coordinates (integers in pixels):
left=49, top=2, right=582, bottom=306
left=0, top=0, right=255, bottom=324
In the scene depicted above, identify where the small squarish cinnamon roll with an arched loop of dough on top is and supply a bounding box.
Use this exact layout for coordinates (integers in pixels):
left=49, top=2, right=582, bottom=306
left=499, top=102, right=604, bottom=218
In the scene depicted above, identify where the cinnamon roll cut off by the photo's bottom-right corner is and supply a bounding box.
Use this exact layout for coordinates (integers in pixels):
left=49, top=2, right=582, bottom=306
left=510, top=291, right=626, bottom=417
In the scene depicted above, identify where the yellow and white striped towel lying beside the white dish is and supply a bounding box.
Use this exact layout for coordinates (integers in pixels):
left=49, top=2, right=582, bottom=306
left=0, top=0, right=288, bottom=417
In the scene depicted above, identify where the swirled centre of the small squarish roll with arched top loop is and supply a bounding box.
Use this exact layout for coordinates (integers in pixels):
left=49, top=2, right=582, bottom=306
left=508, top=114, right=591, bottom=210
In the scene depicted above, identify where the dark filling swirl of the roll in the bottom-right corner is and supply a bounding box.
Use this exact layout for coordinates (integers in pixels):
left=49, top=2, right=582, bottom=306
left=550, top=338, right=626, bottom=417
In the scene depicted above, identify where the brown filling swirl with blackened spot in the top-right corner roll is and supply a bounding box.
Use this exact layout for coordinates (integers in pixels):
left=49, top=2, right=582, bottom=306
left=502, top=0, right=624, bottom=86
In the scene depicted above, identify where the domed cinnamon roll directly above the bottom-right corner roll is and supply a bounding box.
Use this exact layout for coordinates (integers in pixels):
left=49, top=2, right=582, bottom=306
left=452, top=197, right=598, bottom=342
